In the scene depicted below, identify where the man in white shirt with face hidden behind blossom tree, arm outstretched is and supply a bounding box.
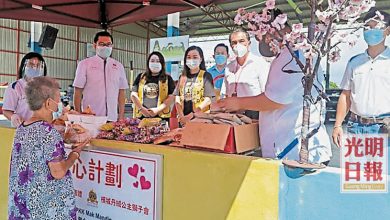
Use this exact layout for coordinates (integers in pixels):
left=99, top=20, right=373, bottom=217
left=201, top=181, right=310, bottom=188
left=219, top=10, right=332, bottom=165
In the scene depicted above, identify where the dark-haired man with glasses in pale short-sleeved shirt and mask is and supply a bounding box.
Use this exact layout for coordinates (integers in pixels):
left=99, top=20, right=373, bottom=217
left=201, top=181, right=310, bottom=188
left=73, top=31, right=129, bottom=121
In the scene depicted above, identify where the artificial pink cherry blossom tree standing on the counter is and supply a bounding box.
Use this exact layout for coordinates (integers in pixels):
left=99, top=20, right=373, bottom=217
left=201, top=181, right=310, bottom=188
left=234, top=0, right=384, bottom=169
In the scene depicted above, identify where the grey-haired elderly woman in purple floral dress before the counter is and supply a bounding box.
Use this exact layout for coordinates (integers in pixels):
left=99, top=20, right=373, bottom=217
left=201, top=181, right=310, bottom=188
left=8, top=76, right=85, bottom=219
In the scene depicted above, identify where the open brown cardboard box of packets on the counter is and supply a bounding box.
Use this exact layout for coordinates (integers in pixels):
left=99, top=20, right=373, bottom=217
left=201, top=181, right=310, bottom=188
left=180, top=122, right=260, bottom=153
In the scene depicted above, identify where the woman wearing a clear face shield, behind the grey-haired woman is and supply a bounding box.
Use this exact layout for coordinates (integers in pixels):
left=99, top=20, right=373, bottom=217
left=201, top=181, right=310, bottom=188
left=3, top=52, right=47, bottom=127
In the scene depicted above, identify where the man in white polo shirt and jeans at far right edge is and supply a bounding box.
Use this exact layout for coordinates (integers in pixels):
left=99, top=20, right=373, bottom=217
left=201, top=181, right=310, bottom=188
left=333, top=8, right=390, bottom=146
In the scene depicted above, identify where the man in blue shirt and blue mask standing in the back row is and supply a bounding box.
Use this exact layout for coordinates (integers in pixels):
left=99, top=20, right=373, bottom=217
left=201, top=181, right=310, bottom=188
left=207, top=43, right=229, bottom=97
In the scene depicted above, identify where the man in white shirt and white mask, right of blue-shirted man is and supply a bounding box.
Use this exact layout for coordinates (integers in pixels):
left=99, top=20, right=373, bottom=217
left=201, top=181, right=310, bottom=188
left=221, top=28, right=269, bottom=119
